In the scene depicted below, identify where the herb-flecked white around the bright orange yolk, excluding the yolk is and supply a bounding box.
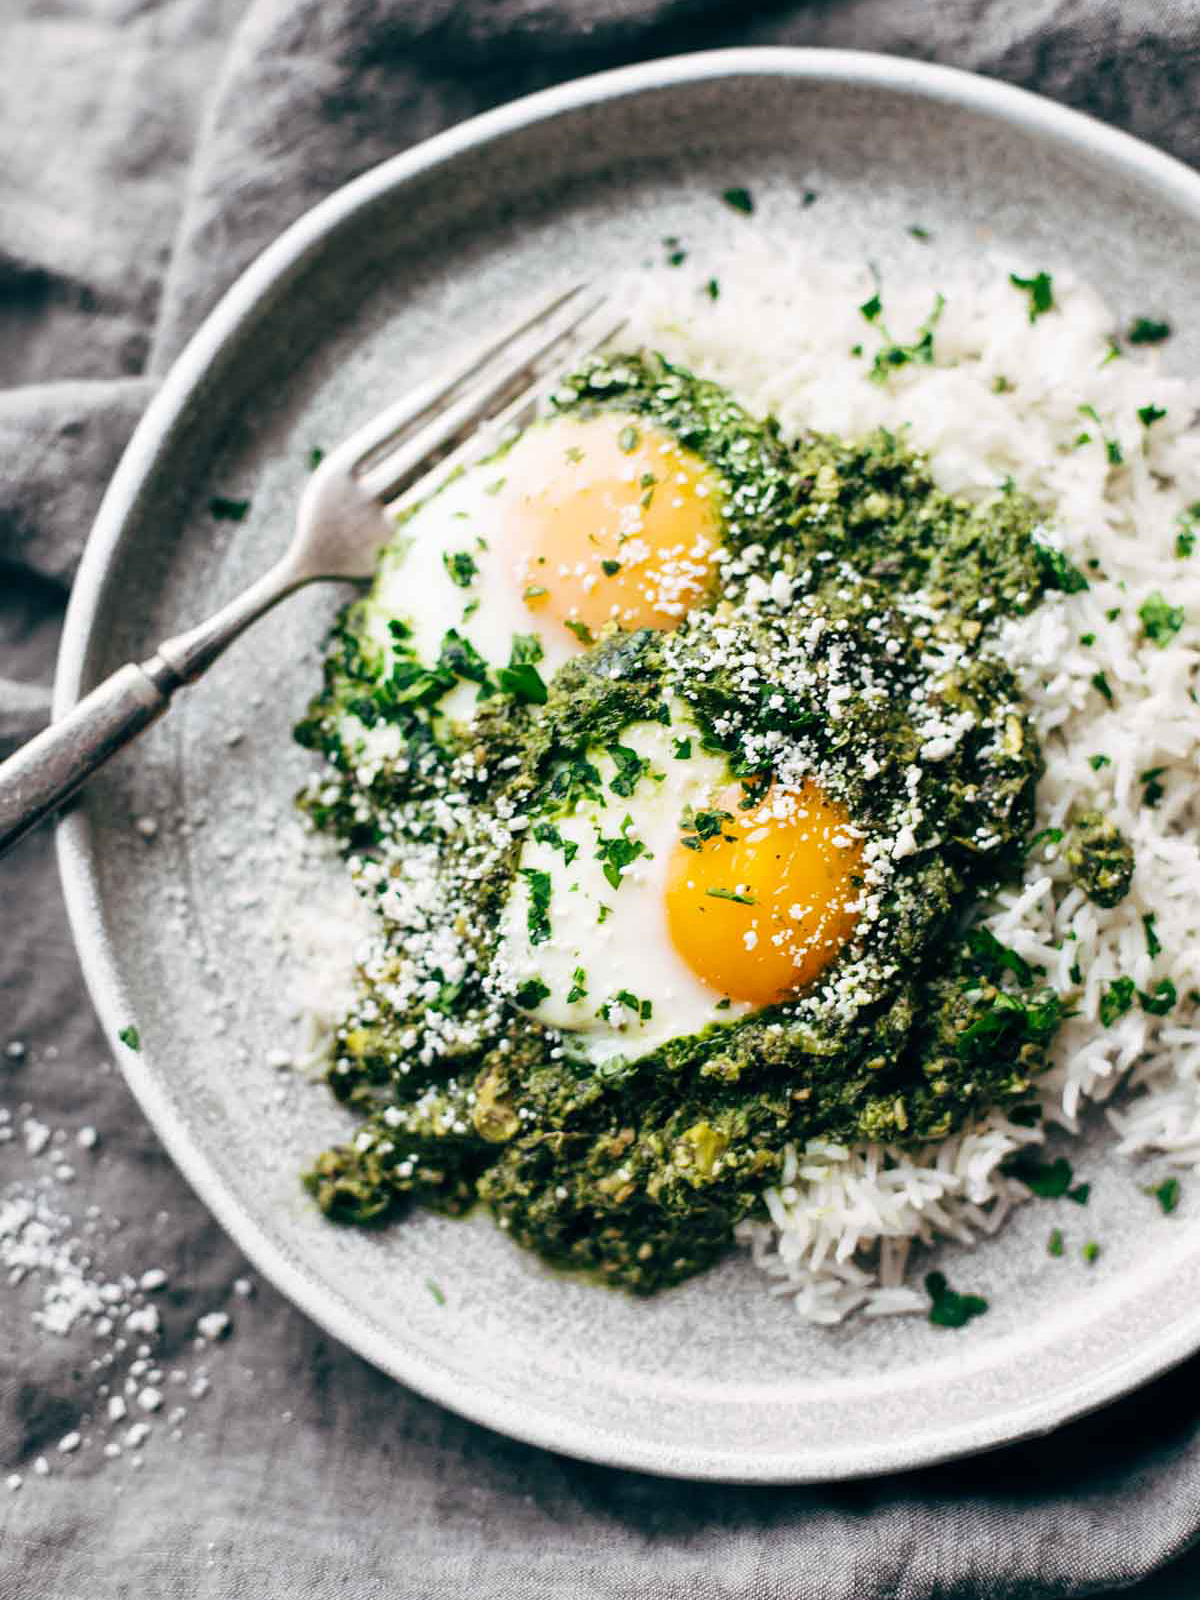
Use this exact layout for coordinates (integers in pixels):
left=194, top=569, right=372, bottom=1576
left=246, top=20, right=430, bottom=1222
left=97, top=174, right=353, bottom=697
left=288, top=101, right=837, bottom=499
left=496, top=701, right=752, bottom=1061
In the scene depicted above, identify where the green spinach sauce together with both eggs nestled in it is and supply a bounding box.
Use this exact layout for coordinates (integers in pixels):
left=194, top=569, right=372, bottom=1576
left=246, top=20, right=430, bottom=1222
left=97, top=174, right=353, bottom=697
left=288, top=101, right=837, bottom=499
left=299, top=354, right=1112, bottom=1293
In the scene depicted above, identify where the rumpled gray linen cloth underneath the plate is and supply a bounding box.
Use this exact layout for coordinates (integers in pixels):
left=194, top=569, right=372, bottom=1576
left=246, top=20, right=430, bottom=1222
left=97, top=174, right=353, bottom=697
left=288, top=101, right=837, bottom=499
left=0, top=0, right=1200, bottom=1600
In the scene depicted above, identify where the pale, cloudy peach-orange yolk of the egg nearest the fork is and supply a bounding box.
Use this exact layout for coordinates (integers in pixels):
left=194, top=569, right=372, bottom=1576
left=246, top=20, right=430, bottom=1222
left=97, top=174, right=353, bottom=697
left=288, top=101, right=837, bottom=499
left=504, top=411, right=720, bottom=643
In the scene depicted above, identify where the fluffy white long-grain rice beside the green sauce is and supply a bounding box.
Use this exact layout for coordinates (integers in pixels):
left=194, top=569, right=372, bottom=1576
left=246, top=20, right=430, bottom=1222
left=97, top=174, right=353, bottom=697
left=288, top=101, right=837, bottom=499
left=622, top=243, right=1200, bottom=1323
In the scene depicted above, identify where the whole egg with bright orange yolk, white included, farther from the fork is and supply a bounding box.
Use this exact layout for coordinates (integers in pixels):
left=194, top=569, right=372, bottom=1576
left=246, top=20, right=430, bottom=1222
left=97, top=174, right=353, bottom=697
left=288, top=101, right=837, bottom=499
left=496, top=701, right=862, bottom=1061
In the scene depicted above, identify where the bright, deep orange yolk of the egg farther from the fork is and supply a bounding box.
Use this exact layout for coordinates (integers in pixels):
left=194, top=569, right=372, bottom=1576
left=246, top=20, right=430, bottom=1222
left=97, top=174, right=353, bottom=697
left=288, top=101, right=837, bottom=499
left=666, top=782, right=862, bottom=1006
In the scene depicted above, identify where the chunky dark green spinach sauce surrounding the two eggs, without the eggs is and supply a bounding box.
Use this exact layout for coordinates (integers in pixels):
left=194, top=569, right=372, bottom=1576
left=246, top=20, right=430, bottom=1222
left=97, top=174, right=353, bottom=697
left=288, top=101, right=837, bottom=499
left=298, top=355, right=1115, bottom=1293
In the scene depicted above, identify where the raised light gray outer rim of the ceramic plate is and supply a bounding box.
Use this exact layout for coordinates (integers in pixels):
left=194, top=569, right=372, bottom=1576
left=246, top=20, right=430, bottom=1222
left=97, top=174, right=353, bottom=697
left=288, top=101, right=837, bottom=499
left=54, top=48, right=1200, bottom=1483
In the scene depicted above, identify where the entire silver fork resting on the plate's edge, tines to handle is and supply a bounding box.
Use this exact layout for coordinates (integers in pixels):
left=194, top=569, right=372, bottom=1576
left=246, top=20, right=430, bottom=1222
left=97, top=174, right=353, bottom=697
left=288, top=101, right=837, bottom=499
left=0, top=285, right=624, bottom=854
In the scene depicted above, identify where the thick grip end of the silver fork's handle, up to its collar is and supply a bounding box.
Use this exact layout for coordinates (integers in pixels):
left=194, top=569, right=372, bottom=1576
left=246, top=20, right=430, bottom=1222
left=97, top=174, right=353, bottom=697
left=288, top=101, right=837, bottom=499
left=0, top=656, right=179, bottom=856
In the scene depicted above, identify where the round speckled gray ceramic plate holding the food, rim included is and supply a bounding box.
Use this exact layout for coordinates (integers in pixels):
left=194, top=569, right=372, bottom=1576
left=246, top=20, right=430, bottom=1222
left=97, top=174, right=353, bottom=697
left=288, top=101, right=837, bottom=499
left=58, top=50, right=1200, bottom=1482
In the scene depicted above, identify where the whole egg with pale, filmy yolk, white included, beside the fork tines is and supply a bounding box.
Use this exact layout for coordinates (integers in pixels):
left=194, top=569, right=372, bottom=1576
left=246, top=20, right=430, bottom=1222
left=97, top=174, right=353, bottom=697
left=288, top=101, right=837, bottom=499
left=366, top=411, right=722, bottom=720
